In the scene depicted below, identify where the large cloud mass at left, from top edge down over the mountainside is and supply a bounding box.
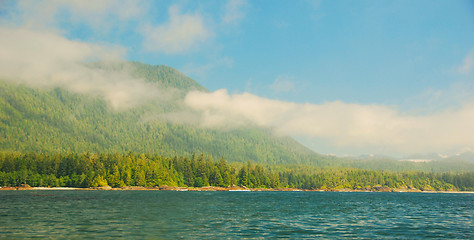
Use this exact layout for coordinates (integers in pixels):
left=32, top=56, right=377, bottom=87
left=0, top=0, right=177, bottom=110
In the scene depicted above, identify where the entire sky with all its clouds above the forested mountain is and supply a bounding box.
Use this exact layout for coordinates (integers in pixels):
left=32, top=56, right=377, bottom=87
left=0, top=0, right=474, bottom=156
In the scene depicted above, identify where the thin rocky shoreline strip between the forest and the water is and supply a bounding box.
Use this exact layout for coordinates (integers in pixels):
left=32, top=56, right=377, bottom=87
left=0, top=186, right=474, bottom=194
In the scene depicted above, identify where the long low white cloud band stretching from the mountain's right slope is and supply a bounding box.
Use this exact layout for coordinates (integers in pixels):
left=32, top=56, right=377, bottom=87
left=185, top=90, right=474, bottom=154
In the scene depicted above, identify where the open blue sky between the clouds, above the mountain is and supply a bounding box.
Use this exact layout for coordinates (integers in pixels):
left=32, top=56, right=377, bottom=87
left=61, top=1, right=474, bottom=105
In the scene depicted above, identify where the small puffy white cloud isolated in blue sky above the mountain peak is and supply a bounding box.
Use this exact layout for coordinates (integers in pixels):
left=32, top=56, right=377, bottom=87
left=141, top=6, right=212, bottom=54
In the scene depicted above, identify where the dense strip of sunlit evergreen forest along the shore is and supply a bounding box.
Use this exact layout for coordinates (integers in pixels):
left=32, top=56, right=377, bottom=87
left=0, top=152, right=474, bottom=191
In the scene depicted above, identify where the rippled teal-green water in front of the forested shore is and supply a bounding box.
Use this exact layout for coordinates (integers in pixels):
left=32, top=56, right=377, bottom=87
left=0, top=190, right=474, bottom=239
